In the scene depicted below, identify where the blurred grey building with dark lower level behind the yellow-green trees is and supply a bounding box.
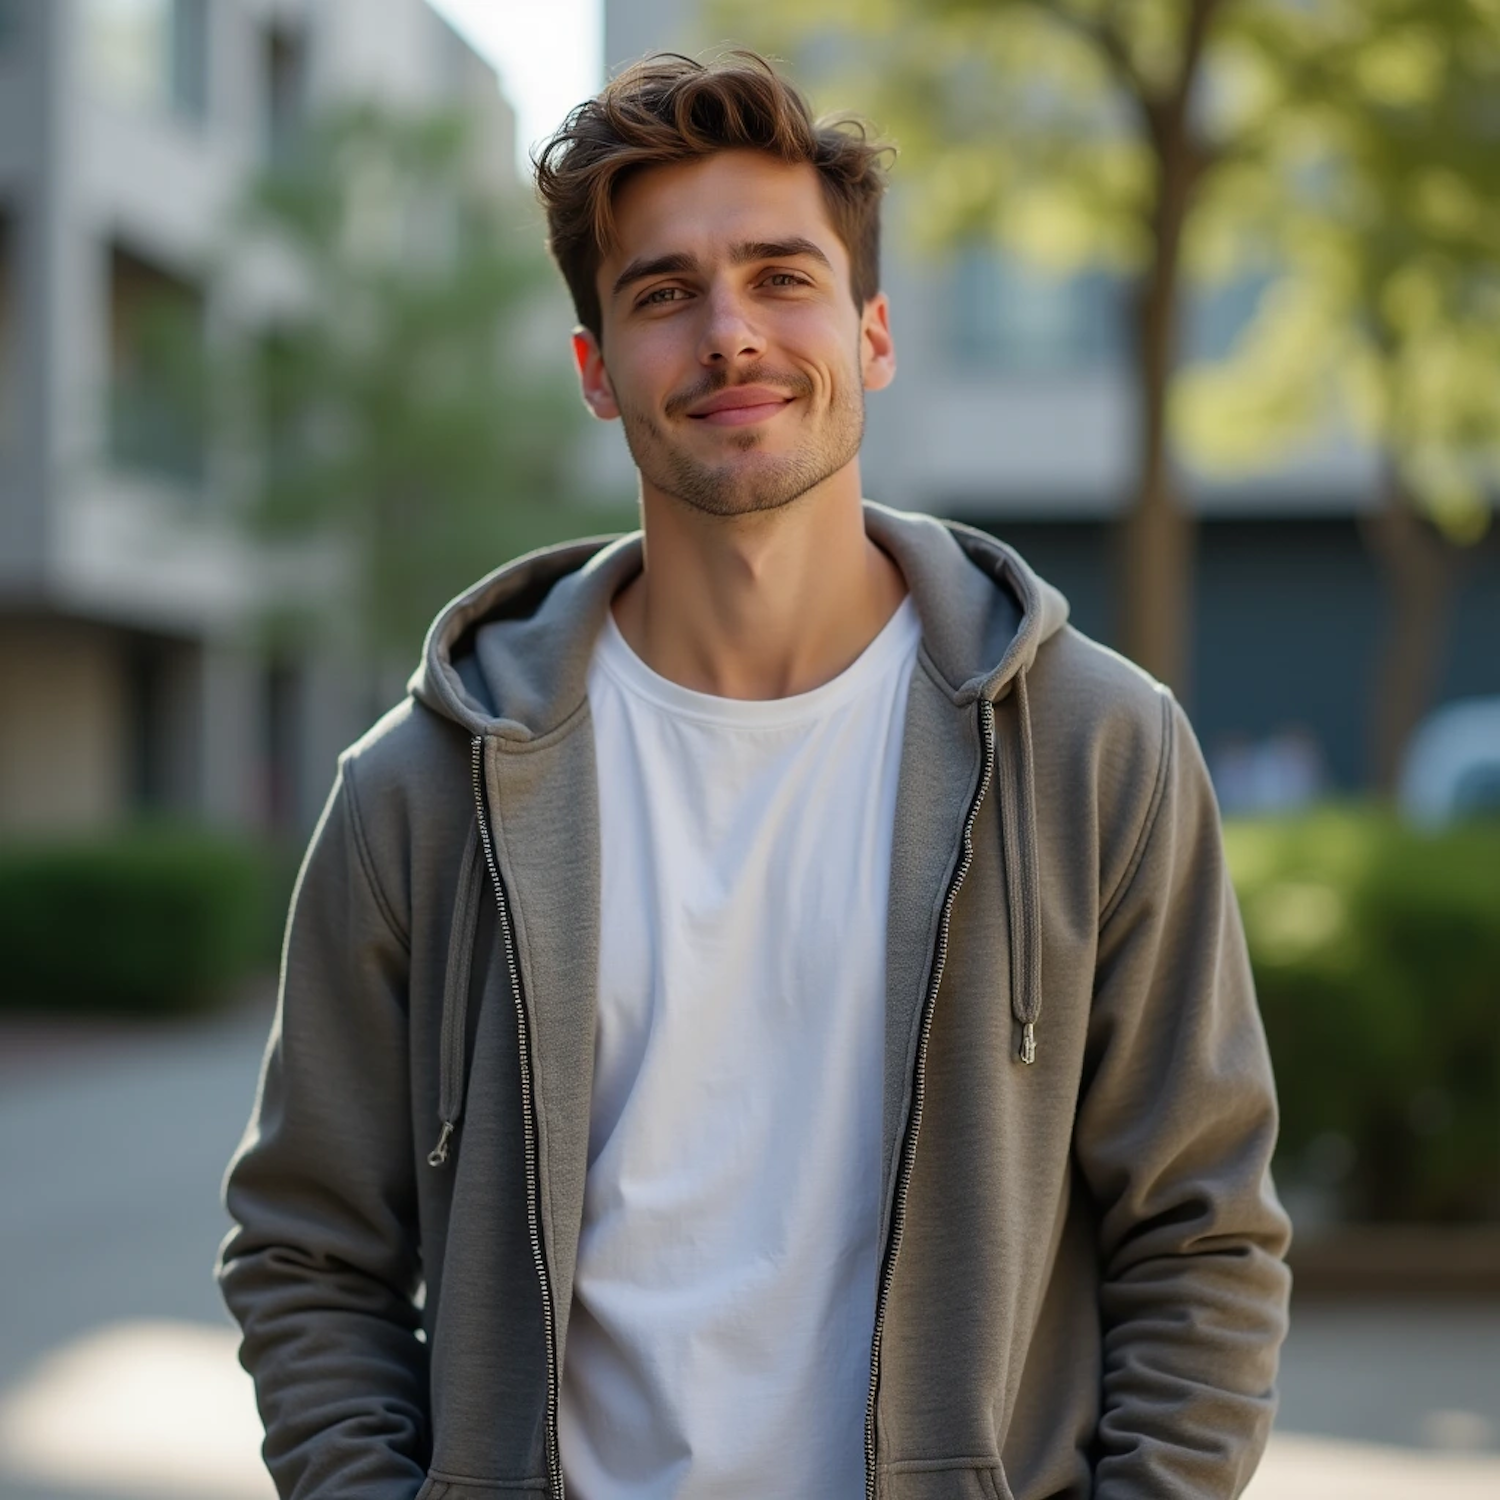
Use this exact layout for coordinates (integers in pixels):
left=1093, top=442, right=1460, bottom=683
left=605, top=0, right=1500, bottom=791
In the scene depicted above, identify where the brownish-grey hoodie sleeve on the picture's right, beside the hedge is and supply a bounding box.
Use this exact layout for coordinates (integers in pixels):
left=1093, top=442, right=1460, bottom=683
left=1076, top=693, right=1290, bottom=1500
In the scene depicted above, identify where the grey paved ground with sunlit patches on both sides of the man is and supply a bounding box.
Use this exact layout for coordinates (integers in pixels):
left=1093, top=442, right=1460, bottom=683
left=0, top=1008, right=1500, bottom=1500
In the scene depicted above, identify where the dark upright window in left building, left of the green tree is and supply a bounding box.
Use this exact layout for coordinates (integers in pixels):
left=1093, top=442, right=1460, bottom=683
left=110, top=245, right=206, bottom=486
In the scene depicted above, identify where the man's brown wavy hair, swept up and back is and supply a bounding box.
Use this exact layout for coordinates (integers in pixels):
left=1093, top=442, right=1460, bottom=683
left=533, top=51, right=894, bottom=339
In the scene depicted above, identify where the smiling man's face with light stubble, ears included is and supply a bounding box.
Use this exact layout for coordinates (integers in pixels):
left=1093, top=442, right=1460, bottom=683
left=575, top=152, right=896, bottom=516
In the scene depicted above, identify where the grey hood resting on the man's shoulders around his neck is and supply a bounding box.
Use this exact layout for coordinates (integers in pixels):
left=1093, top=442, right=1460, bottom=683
left=410, top=501, right=1068, bottom=741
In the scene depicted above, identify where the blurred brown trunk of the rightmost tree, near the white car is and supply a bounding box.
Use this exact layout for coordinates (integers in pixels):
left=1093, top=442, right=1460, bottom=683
left=1361, top=476, right=1458, bottom=801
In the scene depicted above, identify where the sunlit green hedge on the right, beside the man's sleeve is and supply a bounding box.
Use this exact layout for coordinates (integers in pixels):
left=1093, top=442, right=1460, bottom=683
left=1226, top=809, right=1500, bottom=1223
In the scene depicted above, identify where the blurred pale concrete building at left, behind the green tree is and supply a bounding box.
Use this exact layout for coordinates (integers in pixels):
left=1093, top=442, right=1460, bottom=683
left=0, top=0, right=515, bottom=833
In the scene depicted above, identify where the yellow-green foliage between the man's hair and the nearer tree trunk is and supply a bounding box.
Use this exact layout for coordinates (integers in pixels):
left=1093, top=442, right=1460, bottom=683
left=723, top=0, right=1158, bottom=273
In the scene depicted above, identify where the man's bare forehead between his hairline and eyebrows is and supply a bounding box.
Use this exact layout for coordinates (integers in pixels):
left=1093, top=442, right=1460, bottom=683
left=600, top=152, right=849, bottom=287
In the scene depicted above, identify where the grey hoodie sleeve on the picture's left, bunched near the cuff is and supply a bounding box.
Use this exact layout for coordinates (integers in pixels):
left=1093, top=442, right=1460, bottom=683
left=216, top=758, right=431, bottom=1500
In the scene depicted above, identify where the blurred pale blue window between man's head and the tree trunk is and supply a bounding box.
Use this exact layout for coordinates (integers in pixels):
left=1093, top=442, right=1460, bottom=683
left=948, top=246, right=1122, bottom=375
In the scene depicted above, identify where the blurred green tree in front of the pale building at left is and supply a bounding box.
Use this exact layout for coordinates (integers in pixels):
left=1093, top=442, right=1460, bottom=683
left=223, top=107, right=614, bottom=662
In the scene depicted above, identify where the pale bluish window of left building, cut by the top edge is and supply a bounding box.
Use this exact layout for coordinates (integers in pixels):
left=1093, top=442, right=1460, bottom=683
left=86, top=0, right=210, bottom=125
